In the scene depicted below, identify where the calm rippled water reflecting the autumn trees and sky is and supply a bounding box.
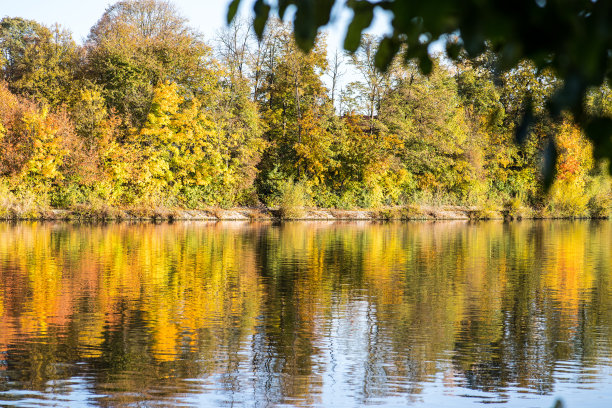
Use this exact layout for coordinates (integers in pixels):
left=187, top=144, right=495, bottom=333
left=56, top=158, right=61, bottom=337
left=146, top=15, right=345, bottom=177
left=0, top=222, right=612, bottom=408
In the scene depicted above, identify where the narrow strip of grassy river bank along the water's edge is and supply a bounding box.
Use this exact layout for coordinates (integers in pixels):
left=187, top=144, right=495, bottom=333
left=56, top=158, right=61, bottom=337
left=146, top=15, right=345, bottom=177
left=0, top=205, right=608, bottom=221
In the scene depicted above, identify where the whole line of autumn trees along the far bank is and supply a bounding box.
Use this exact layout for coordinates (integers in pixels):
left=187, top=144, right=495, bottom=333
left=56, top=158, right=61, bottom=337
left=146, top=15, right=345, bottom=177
left=0, top=0, right=612, bottom=216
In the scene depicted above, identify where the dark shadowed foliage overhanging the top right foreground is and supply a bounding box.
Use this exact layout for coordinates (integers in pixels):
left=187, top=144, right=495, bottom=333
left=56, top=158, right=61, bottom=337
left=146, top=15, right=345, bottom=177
left=228, top=0, right=612, bottom=173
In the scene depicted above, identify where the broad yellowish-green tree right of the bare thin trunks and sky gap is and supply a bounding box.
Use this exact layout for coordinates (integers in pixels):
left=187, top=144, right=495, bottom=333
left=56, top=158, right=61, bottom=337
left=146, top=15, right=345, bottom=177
left=380, top=58, right=476, bottom=198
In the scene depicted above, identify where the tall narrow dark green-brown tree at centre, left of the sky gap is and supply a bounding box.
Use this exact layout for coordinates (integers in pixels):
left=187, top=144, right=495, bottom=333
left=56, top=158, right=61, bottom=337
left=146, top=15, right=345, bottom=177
left=252, top=22, right=333, bottom=187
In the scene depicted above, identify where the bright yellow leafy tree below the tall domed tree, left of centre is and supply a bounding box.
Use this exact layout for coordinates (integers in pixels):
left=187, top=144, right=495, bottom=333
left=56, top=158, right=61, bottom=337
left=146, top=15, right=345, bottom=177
left=123, top=83, right=261, bottom=206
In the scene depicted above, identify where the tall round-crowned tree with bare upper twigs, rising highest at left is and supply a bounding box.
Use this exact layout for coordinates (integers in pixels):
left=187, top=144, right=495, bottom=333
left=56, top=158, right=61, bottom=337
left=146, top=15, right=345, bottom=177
left=85, top=0, right=212, bottom=127
